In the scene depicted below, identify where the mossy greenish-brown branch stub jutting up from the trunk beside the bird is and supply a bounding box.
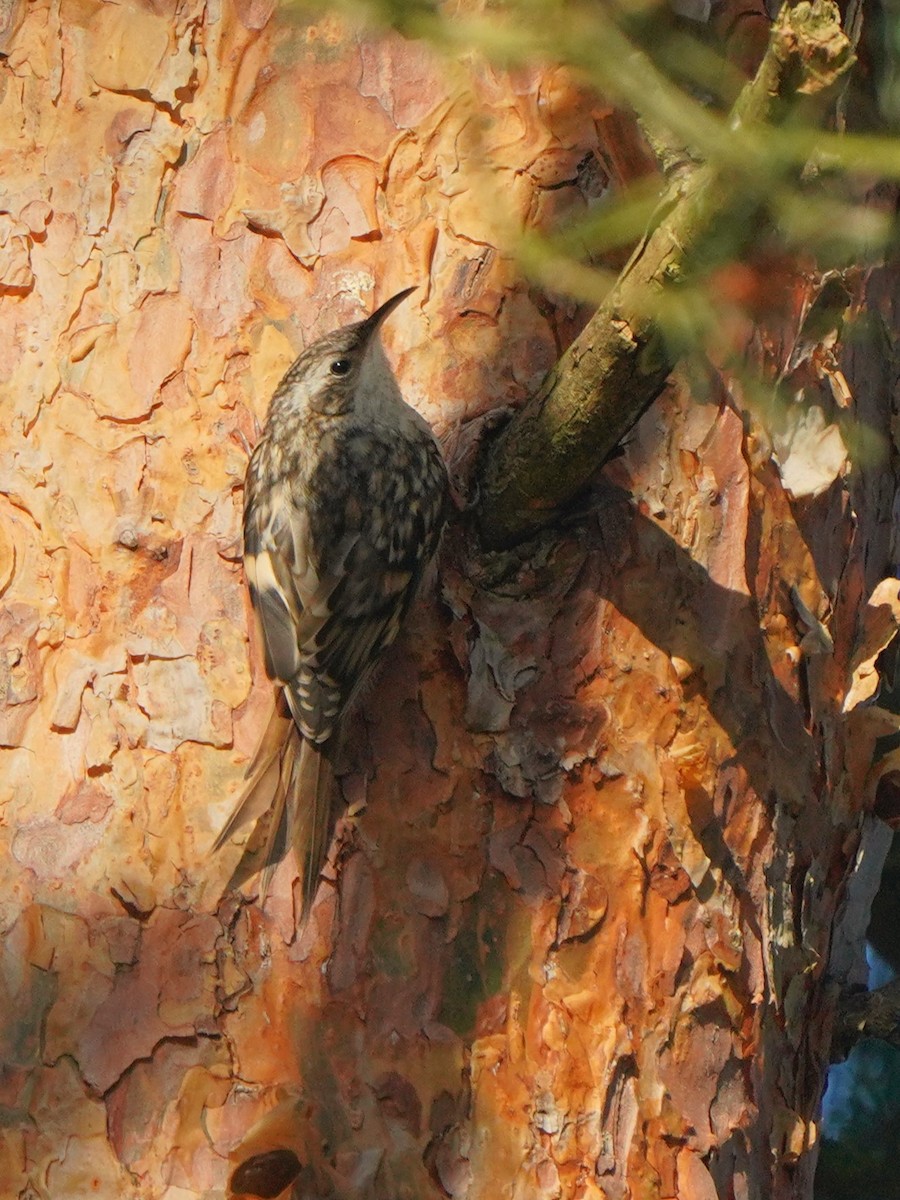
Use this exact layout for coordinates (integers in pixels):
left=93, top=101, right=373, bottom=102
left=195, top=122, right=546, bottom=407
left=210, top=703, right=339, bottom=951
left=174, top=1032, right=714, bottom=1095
left=476, top=0, right=853, bottom=548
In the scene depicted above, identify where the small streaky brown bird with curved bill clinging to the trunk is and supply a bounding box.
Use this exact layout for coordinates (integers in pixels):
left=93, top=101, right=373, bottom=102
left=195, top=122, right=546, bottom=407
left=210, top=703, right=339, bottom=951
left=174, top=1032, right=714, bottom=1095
left=216, top=288, right=449, bottom=907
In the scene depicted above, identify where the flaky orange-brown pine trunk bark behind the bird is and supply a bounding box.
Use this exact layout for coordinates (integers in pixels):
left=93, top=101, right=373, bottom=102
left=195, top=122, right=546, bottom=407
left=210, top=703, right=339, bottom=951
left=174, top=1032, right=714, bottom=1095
left=0, top=0, right=900, bottom=1200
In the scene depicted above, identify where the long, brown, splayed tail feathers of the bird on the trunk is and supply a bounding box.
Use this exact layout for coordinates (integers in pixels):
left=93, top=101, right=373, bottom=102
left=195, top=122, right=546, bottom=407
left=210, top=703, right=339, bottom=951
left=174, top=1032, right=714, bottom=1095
left=214, top=697, right=337, bottom=914
